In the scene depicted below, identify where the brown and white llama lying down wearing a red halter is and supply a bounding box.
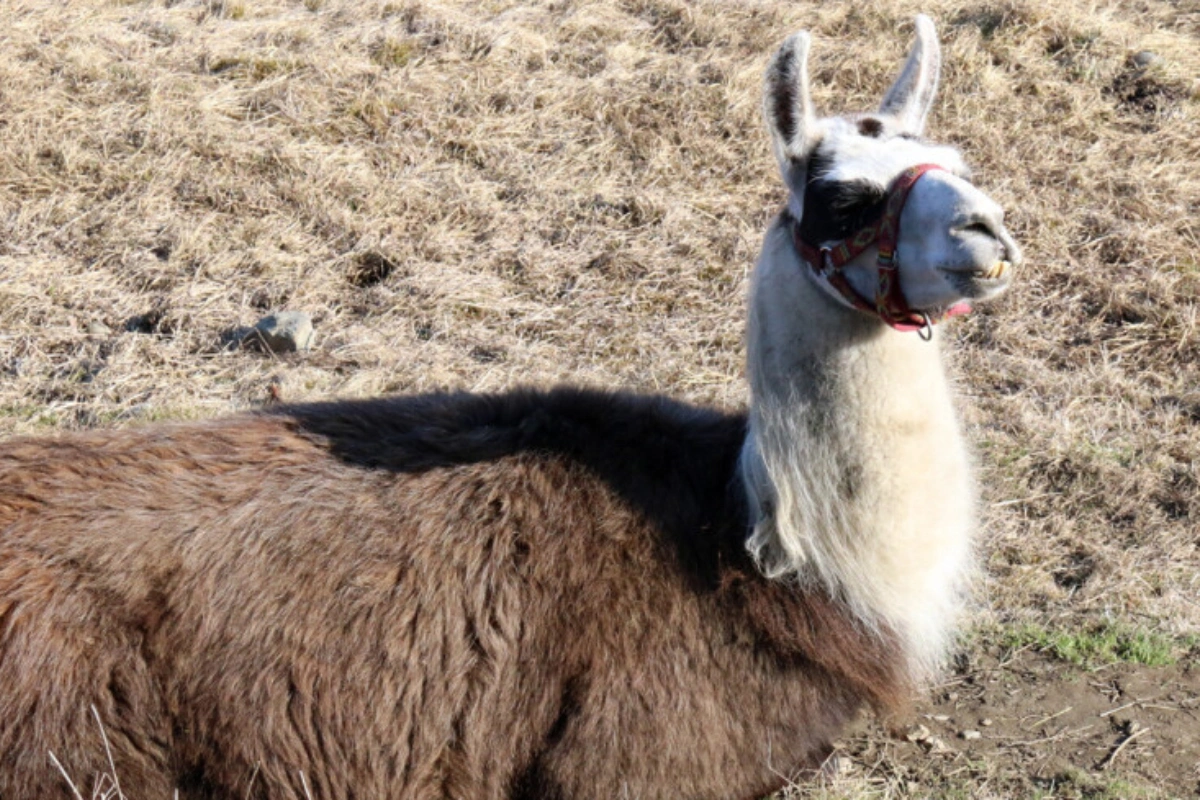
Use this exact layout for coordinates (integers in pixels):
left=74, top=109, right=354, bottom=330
left=0, top=17, right=1020, bottom=800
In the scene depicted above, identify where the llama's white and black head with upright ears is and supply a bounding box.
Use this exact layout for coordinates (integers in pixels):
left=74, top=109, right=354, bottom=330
left=764, top=14, right=1021, bottom=330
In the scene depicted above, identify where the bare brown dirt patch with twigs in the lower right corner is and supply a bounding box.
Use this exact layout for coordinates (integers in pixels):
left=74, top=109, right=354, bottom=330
left=785, top=648, right=1200, bottom=800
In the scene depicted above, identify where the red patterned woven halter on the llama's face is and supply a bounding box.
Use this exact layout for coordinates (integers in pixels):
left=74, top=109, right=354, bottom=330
left=792, top=164, right=971, bottom=339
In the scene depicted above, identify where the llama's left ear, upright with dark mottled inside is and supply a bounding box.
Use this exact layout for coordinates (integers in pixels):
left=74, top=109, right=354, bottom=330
left=763, top=31, right=817, bottom=193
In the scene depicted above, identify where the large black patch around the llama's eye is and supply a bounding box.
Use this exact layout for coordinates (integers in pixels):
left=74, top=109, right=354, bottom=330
left=800, top=148, right=888, bottom=246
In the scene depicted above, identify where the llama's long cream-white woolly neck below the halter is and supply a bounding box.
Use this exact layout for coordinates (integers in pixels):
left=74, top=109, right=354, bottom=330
left=740, top=223, right=974, bottom=678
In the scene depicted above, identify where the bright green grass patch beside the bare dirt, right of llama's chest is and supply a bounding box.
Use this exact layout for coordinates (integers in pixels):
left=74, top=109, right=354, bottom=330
left=1001, top=622, right=1180, bottom=667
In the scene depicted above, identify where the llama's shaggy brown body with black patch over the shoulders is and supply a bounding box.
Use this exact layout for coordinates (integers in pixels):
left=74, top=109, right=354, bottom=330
left=0, top=390, right=902, bottom=800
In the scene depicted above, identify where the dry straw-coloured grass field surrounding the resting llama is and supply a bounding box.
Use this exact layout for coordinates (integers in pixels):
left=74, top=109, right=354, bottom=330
left=0, top=0, right=1200, bottom=800
